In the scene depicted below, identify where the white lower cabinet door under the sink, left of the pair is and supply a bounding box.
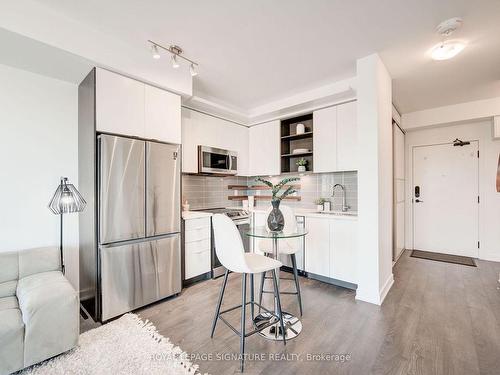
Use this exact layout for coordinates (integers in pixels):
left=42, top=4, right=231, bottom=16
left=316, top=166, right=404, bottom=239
left=305, top=217, right=330, bottom=277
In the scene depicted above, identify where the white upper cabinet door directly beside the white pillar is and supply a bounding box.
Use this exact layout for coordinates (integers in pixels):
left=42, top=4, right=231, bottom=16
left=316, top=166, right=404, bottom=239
left=336, top=102, right=358, bottom=171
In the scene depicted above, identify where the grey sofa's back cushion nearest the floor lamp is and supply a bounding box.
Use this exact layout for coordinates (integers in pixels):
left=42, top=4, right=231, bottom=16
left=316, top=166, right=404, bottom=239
left=18, top=246, right=61, bottom=279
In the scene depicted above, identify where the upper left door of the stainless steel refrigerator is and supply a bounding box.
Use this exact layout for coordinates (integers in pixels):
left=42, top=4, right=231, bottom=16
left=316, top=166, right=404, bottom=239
left=99, top=135, right=145, bottom=244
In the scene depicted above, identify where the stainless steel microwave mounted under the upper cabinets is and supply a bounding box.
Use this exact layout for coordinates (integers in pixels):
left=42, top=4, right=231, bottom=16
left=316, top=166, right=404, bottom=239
left=198, top=146, right=238, bottom=175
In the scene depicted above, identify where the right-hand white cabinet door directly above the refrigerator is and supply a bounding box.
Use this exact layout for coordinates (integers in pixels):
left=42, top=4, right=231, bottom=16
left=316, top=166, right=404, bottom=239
left=144, top=85, right=181, bottom=144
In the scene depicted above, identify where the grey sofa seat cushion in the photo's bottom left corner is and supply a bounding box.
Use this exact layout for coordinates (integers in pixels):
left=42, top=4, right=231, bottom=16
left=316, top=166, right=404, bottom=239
left=0, top=308, right=24, bottom=375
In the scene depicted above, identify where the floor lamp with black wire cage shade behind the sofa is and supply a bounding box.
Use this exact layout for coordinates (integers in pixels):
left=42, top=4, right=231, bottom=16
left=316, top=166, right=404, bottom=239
left=49, top=177, right=87, bottom=274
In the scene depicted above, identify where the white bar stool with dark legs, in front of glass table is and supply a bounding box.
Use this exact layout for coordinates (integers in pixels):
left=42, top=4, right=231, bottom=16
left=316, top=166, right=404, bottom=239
left=210, top=214, right=286, bottom=372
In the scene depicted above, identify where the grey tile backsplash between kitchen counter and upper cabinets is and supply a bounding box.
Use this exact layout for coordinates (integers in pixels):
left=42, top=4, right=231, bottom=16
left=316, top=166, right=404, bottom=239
left=182, top=171, right=358, bottom=211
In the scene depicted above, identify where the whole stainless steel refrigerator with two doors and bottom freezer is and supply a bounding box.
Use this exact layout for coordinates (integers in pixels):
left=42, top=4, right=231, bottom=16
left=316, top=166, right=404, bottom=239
left=97, top=134, right=181, bottom=321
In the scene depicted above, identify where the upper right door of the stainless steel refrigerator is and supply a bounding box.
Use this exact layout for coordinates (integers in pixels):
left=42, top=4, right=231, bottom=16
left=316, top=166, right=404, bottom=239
left=146, top=142, right=181, bottom=236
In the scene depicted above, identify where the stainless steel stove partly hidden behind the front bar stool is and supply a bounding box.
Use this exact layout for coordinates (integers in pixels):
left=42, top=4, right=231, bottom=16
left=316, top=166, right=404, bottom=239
left=197, top=207, right=250, bottom=279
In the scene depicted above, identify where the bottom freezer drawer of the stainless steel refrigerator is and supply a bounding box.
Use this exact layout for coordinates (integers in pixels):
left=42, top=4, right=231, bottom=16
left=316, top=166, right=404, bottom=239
left=99, top=234, right=181, bottom=321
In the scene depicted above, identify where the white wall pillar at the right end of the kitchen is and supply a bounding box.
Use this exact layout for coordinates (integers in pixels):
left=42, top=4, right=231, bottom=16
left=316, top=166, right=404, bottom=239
left=356, top=54, right=394, bottom=304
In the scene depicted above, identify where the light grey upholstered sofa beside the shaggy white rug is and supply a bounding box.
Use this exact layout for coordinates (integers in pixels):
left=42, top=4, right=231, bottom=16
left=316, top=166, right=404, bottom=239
left=0, top=247, right=80, bottom=375
